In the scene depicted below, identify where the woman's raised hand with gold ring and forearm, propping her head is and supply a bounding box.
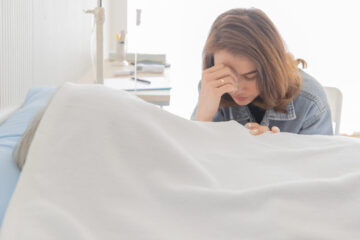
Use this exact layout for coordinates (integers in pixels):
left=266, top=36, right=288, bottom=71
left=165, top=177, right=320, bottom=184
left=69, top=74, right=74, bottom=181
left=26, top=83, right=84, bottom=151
left=195, top=64, right=237, bottom=121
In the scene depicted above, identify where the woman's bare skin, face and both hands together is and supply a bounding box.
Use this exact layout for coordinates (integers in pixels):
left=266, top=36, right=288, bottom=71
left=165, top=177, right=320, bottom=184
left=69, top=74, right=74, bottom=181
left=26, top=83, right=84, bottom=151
left=195, top=50, right=280, bottom=135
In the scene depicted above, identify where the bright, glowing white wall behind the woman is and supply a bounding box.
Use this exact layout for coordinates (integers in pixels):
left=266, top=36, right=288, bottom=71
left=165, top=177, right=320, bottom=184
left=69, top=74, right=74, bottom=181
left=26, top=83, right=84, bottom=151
left=128, top=0, right=360, bottom=133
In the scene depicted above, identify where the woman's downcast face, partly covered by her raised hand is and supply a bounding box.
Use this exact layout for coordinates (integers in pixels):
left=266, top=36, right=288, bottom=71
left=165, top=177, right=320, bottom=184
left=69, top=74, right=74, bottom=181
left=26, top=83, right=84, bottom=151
left=214, top=50, right=260, bottom=106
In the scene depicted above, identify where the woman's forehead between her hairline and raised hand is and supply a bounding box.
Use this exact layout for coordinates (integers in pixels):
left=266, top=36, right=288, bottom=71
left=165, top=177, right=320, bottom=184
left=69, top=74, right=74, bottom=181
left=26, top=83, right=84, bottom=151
left=214, top=50, right=256, bottom=75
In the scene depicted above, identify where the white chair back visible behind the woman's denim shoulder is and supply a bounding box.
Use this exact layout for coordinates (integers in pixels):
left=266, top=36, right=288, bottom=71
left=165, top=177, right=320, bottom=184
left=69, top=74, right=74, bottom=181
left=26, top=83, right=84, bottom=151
left=324, top=87, right=342, bottom=135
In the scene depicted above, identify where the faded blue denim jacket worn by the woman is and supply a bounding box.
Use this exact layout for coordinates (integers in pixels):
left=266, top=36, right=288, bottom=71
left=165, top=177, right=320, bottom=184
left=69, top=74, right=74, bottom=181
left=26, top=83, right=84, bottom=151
left=191, top=70, right=333, bottom=135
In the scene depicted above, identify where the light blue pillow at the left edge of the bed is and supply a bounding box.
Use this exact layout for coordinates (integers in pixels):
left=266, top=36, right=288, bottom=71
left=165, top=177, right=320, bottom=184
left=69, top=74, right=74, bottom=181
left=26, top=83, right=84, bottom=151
left=0, top=86, right=55, bottom=226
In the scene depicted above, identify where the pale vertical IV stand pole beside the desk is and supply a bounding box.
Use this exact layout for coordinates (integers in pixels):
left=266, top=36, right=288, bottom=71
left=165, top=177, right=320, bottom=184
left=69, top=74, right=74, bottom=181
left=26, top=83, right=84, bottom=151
left=85, top=0, right=105, bottom=84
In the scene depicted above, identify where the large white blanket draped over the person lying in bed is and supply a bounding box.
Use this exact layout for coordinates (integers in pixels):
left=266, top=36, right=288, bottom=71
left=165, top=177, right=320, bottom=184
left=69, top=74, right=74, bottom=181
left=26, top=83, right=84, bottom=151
left=2, top=84, right=360, bottom=240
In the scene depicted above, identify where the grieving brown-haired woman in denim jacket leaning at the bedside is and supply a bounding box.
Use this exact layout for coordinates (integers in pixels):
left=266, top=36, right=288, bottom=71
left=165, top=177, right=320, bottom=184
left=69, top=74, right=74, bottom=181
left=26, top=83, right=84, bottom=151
left=192, top=8, right=333, bottom=135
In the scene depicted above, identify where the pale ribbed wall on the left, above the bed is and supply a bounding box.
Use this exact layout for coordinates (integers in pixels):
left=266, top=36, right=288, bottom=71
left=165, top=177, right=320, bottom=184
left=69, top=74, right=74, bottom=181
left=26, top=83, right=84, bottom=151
left=0, top=0, right=97, bottom=108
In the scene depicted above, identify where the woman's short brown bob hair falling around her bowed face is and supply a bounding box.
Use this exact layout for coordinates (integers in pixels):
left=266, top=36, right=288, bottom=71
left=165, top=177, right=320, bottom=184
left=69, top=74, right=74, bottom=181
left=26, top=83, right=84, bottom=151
left=203, top=8, right=306, bottom=112
